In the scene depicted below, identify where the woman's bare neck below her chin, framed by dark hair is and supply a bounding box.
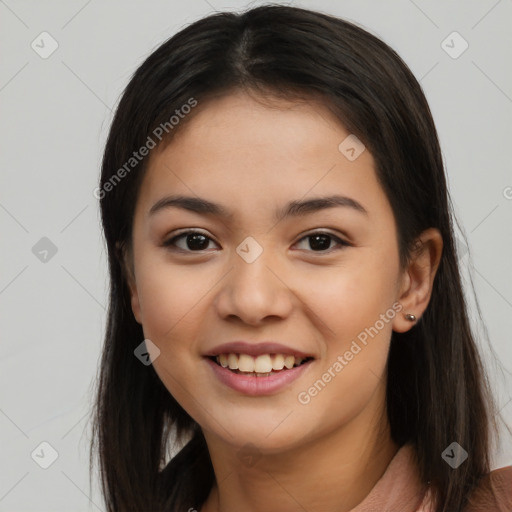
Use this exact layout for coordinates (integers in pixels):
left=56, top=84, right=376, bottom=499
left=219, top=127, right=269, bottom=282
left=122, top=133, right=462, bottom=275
left=201, top=400, right=399, bottom=512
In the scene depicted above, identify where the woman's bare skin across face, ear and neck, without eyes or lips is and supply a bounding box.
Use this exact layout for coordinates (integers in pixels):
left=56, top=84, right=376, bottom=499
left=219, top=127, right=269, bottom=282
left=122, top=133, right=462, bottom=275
left=122, top=92, right=442, bottom=512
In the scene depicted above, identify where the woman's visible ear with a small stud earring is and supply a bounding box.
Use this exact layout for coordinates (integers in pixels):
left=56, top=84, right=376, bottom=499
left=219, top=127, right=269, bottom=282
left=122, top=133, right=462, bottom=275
left=393, top=228, right=443, bottom=332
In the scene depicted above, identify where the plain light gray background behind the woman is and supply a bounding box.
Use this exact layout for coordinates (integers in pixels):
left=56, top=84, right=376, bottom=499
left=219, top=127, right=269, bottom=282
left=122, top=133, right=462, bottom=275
left=0, top=0, right=512, bottom=512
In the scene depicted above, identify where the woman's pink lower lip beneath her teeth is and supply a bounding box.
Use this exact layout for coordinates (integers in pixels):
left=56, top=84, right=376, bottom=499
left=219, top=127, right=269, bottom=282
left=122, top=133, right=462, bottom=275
left=206, top=358, right=313, bottom=396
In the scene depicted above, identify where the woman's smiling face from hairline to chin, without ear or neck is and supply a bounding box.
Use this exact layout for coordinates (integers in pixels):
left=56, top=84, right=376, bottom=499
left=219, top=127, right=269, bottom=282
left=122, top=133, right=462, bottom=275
left=127, top=93, right=408, bottom=454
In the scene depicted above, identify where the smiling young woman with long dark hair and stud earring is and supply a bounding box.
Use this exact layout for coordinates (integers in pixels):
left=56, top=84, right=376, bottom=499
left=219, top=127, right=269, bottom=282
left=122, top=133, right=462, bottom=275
left=91, top=6, right=512, bottom=512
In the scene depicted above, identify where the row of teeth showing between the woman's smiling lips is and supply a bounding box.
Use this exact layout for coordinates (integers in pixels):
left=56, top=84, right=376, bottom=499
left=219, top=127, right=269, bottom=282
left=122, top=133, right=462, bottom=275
left=210, top=353, right=313, bottom=377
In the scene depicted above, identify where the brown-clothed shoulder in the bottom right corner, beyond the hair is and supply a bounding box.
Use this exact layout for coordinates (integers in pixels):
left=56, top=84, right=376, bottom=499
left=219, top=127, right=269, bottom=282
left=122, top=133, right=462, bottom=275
left=464, top=466, right=512, bottom=512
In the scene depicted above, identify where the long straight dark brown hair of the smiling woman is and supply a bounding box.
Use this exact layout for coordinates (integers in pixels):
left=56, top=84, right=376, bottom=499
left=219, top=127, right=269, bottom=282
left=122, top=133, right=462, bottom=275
left=91, top=5, right=506, bottom=512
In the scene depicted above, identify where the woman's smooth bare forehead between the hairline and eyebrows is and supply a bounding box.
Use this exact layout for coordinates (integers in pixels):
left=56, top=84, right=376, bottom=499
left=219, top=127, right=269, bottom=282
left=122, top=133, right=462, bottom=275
left=134, top=93, right=388, bottom=226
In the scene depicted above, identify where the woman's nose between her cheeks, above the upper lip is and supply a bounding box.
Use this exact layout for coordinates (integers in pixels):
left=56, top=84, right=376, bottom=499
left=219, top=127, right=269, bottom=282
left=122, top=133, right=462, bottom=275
left=215, top=246, right=293, bottom=326
